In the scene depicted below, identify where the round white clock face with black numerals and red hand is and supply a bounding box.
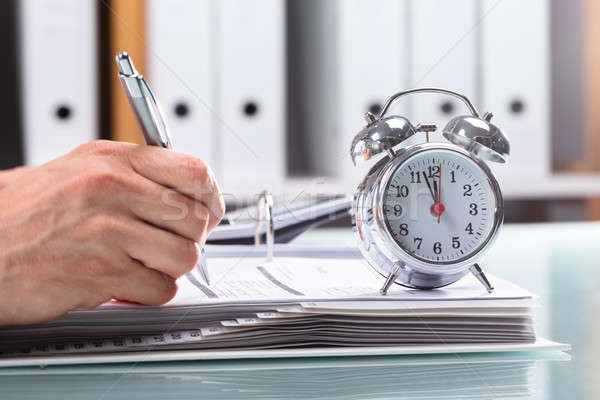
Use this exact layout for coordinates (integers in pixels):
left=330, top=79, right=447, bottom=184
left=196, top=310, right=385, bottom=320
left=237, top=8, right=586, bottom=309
left=383, top=149, right=496, bottom=264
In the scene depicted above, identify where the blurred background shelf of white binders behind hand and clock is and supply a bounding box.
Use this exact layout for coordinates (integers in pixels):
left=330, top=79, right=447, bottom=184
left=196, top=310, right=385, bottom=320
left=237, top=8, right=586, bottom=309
left=0, top=0, right=600, bottom=222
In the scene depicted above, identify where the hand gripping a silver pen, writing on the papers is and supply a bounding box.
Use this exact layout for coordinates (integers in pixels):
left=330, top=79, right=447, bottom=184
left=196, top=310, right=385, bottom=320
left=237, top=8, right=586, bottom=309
left=0, top=141, right=225, bottom=326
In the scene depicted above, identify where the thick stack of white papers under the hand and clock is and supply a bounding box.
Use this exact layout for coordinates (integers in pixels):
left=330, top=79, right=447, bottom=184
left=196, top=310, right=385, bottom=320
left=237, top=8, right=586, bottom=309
left=0, top=246, right=564, bottom=364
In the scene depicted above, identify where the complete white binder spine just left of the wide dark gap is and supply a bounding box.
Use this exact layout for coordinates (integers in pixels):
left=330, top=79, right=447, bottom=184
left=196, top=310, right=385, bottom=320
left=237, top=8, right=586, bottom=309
left=215, top=0, right=286, bottom=196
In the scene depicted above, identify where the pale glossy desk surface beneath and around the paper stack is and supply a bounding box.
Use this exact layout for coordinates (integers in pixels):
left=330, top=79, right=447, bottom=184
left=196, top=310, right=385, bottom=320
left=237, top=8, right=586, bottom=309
left=0, top=223, right=600, bottom=399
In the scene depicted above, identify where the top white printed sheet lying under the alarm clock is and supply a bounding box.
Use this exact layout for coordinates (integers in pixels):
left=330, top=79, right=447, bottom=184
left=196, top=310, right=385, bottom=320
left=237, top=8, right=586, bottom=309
left=102, top=255, right=535, bottom=309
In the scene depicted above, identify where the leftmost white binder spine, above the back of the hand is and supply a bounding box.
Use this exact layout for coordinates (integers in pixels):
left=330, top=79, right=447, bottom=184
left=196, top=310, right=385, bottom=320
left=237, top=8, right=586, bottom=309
left=19, top=0, right=98, bottom=165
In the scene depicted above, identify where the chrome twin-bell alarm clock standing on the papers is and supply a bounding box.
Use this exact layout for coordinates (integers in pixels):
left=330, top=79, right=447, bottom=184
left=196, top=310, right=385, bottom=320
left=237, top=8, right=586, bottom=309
left=351, top=88, right=510, bottom=294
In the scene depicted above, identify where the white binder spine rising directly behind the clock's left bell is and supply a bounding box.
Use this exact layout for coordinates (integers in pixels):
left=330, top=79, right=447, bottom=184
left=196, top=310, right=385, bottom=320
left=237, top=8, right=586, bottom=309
left=338, top=0, right=410, bottom=188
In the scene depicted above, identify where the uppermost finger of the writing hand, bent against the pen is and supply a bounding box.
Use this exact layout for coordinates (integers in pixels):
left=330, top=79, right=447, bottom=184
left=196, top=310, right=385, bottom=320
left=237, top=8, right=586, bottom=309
left=128, top=146, right=225, bottom=231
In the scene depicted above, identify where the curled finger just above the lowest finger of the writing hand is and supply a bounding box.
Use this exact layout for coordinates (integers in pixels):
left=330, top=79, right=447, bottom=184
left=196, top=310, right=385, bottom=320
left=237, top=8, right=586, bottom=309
left=121, top=220, right=200, bottom=279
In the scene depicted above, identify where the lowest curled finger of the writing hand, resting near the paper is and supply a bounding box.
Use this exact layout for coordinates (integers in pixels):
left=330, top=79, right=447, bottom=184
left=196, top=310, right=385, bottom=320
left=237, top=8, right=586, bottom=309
left=113, top=260, right=177, bottom=306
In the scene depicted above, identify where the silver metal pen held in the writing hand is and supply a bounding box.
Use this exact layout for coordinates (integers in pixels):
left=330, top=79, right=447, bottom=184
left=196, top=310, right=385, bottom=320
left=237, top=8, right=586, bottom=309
left=116, top=51, right=210, bottom=285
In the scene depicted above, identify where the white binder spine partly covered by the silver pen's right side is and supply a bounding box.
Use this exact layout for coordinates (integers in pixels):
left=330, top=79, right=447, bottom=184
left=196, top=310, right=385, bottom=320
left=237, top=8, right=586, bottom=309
left=147, top=0, right=217, bottom=170
